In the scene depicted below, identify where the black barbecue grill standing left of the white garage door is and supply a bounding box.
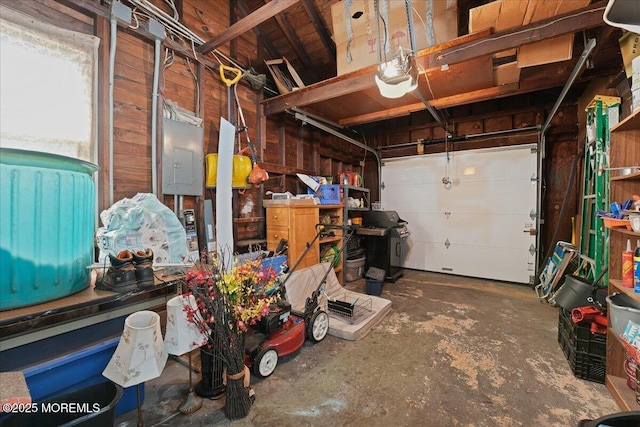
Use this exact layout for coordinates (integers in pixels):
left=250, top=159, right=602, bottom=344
left=356, top=211, right=411, bottom=282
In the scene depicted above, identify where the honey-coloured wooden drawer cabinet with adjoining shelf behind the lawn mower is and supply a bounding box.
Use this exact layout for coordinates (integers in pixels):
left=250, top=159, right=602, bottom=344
left=265, top=200, right=343, bottom=283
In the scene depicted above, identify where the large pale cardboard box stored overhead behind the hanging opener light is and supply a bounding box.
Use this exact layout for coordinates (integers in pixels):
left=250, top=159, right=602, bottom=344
left=331, top=0, right=458, bottom=75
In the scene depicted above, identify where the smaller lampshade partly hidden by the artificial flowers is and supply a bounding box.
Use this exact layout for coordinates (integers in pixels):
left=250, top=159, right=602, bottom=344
left=164, top=295, right=207, bottom=356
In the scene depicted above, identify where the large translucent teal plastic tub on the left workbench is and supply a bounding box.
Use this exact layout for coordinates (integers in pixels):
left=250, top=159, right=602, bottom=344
left=0, top=148, right=98, bottom=311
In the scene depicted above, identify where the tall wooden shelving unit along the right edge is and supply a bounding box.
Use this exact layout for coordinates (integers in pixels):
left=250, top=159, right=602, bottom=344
left=606, top=111, right=640, bottom=411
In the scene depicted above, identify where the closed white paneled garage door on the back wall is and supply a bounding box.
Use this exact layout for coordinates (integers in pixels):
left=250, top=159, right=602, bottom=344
left=381, top=145, right=537, bottom=283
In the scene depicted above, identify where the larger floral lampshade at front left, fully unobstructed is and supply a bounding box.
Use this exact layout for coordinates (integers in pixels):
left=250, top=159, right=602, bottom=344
left=102, top=310, right=168, bottom=387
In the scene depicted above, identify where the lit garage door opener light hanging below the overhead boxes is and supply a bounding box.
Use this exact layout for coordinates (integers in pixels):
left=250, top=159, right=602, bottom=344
left=375, top=48, right=418, bottom=98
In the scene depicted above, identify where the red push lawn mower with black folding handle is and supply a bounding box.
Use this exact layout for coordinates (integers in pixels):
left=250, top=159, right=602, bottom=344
left=244, top=224, right=353, bottom=378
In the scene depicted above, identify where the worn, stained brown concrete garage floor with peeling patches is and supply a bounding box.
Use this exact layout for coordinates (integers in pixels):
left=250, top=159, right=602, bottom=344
left=116, top=271, right=619, bottom=427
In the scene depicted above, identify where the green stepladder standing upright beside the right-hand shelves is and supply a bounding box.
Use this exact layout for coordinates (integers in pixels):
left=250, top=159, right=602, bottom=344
left=580, top=95, right=620, bottom=283
